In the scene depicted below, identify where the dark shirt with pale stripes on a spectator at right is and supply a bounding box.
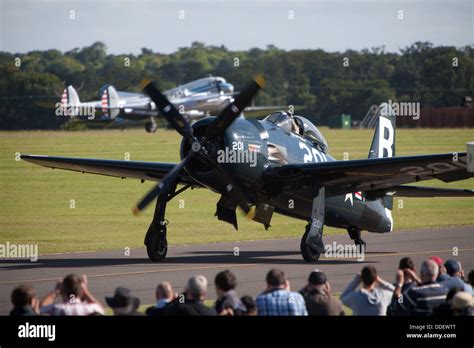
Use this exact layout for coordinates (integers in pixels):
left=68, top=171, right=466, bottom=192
left=403, top=283, right=449, bottom=315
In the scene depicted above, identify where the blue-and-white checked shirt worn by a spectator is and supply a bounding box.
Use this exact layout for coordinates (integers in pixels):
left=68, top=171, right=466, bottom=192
left=256, top=289, right=308, bottom=315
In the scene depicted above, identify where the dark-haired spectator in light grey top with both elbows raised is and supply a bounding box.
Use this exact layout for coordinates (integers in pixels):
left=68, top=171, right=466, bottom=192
left=341, top=266, right=395, bottom=315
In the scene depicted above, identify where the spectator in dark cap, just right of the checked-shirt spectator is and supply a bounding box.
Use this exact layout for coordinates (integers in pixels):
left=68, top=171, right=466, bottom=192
left=300, top=270, right=344, bottom=315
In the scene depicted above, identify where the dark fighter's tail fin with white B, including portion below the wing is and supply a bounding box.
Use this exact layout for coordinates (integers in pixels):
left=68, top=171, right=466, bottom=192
left=369, top=103, right=396, bottom=231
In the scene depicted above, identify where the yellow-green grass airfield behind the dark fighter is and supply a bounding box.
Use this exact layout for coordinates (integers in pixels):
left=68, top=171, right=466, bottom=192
left=0, top=128, right=474, bottom=254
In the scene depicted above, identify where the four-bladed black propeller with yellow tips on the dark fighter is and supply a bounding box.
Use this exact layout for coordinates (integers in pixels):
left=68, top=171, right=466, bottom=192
left=133, top=76, right=265, bottom=219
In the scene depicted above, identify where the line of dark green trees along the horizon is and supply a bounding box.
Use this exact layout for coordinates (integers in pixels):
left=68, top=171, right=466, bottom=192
left=0, top=42, right=474, bottom=129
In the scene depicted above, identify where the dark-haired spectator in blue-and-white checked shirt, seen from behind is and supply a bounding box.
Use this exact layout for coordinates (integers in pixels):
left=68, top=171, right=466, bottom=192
left=256, top=269, right=308, bottom=316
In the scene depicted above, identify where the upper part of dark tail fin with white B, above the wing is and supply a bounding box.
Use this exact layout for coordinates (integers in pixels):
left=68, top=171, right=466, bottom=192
left=369, top=103, right=396, bottom=158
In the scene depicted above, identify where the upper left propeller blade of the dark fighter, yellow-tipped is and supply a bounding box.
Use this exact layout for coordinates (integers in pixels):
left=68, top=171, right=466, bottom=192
left=140, top=80, right=192, bottom=136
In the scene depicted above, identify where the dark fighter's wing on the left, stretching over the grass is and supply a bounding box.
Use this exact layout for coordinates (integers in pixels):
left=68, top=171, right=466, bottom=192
left=21, top=155, right=200, bottom=186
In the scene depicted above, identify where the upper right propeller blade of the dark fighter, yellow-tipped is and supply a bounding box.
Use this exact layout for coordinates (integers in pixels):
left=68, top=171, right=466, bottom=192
left=206, top=75, right=265, bottom=139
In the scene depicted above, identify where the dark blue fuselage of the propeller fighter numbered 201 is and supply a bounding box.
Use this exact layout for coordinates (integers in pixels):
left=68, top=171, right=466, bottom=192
left=188, top=118, right=393, bottom=233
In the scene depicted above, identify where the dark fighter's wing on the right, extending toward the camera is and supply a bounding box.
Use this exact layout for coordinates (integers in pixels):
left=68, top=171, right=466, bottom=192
left=264, top=152, right=474, bottom=195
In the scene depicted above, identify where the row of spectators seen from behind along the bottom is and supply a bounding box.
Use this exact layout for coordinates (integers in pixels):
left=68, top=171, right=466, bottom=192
left=10, top=256, right=474, bottom=316
